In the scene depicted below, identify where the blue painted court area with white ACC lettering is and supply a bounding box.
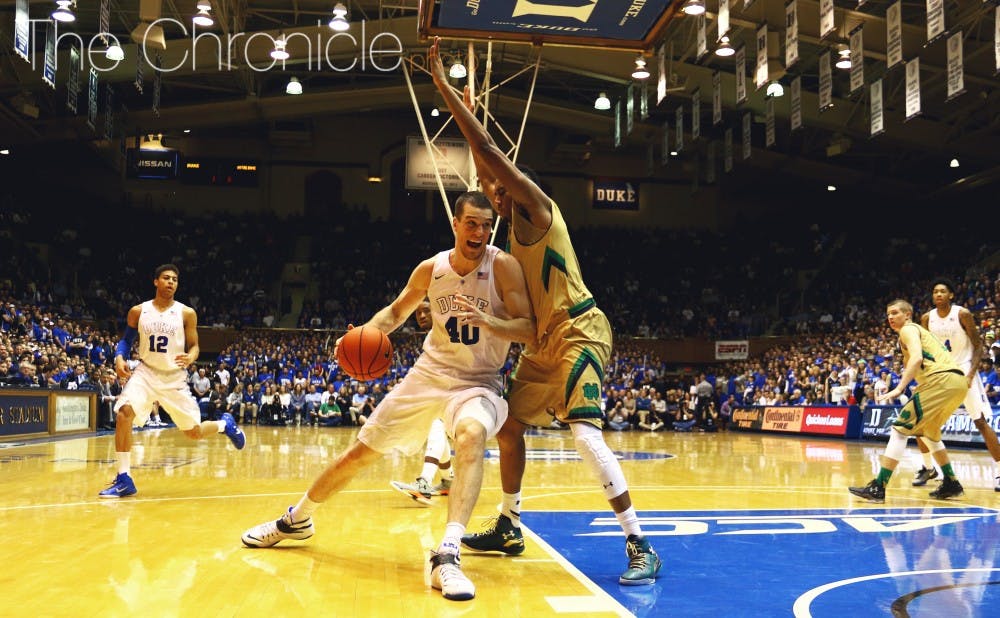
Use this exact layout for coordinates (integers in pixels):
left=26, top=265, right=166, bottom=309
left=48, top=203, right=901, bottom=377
left=521, top=506, right=1000, bottom=618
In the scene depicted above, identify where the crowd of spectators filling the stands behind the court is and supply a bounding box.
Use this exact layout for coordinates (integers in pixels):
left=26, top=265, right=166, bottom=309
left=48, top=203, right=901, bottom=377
left=0, top=196, right=1000, bottom=431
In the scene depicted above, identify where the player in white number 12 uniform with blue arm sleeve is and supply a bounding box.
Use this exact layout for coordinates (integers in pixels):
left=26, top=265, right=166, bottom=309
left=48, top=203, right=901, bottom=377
left=99, top=264, right=246, bottom=498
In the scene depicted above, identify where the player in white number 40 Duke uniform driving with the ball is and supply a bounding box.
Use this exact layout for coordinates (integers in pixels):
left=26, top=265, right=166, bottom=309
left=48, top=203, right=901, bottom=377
left=242, top=191, right=536, bottom=600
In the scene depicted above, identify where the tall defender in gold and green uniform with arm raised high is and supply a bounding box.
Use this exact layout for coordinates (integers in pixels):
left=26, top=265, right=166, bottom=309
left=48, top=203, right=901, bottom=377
left=428, top=40, right=660, bottom=586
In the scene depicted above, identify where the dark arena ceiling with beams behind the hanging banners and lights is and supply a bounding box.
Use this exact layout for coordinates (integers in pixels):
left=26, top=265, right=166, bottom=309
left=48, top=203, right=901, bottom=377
left=0, top=0, right=1000, bottom=197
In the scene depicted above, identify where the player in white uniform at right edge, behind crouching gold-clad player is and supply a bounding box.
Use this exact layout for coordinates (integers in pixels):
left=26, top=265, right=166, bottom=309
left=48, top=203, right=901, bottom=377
left=913, top=279, right=1000, bottom=492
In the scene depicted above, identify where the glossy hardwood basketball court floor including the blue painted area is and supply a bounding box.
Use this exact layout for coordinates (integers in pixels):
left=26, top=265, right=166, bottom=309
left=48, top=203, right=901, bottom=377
left=0, top=427, right=1000, bottom=618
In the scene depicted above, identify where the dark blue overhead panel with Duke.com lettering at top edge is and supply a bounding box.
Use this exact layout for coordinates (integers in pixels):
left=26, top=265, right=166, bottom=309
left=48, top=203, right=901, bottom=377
left=435, top=0, right=672, bottom=41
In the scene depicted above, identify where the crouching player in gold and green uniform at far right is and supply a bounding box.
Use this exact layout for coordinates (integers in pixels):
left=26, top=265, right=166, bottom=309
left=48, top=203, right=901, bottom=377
left=849, top=299, right=969, bottom=502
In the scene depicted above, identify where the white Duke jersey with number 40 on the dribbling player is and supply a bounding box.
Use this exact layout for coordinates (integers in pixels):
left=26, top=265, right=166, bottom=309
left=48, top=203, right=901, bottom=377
left=416, top=245, right=510, bottom=383
